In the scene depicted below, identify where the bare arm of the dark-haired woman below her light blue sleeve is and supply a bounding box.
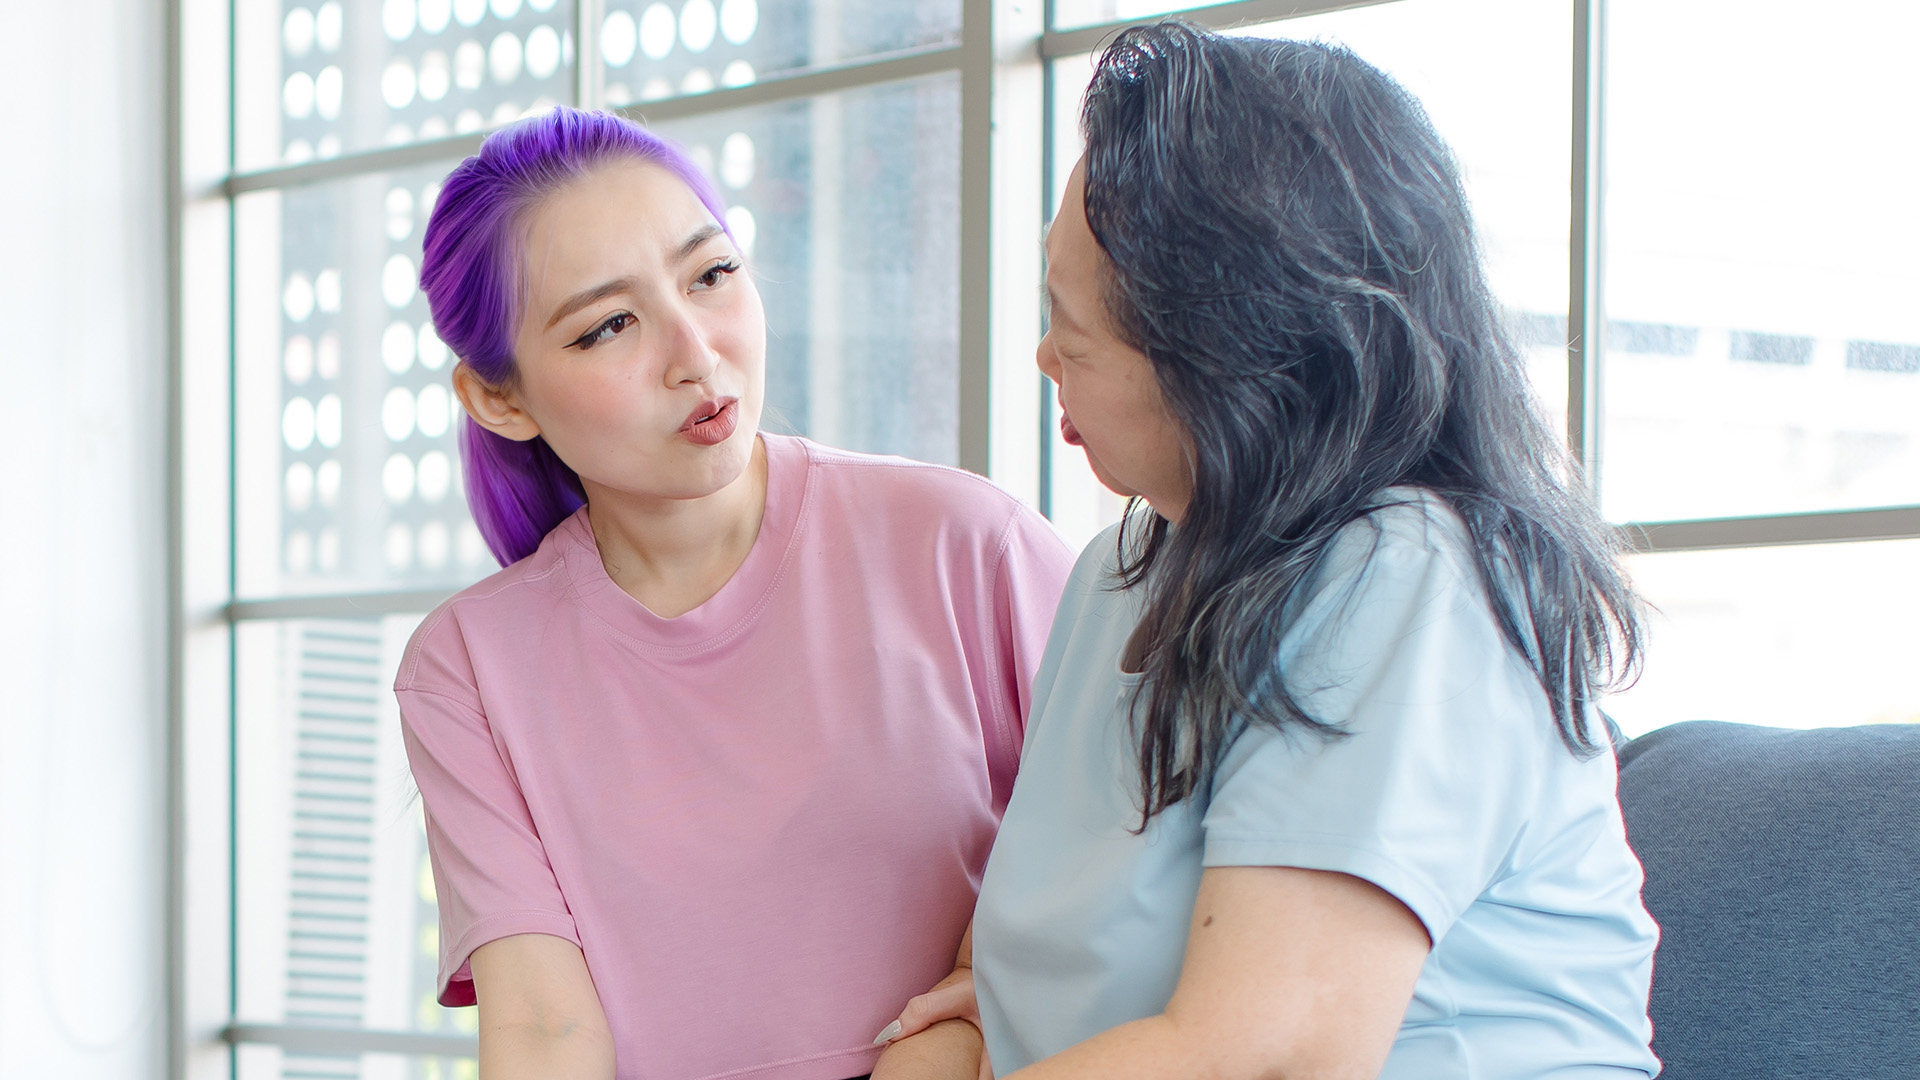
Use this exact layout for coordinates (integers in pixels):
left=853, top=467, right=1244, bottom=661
left=1014, top=867, right=1428, bottom=1080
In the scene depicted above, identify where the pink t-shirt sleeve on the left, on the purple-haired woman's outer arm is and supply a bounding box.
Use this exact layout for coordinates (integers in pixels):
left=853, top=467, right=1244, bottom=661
left=396, top=676, right=580, bottom=1005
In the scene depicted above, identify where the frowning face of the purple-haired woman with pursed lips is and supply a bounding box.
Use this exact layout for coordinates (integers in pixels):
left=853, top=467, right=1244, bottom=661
left=463, top=161, right=766, bottom=500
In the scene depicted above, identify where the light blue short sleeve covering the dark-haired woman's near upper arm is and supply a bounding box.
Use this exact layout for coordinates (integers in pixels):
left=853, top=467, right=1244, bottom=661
left=1204, top=507, right=1557, bottom=942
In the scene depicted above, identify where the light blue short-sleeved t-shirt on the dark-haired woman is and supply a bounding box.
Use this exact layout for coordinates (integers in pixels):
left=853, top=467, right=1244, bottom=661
left=973, top=490, right=1659, bottom=1080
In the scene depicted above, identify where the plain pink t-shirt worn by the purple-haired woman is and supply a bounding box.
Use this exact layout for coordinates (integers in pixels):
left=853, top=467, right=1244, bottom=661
left=394, top=434, right=1073, bottom=1080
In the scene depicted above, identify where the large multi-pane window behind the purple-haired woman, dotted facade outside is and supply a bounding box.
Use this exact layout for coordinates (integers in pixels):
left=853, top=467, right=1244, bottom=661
left=175, top=0, right=1039, bottom=1080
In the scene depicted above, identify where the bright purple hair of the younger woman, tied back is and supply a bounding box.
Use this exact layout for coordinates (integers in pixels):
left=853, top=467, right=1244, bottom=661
left=420, top=106, right=726, bottom=567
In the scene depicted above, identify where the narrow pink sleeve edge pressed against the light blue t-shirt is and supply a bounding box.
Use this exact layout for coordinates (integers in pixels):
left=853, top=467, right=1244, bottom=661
left=993, top=505, right=1075, bottom=809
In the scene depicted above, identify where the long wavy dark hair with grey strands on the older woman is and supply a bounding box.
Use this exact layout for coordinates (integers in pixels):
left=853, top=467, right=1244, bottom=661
left=1081, top=19, right=1642, bottom=828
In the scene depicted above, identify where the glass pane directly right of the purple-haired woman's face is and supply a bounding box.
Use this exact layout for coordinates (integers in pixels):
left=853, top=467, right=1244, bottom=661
left=659, top=75, right=960, bottom=463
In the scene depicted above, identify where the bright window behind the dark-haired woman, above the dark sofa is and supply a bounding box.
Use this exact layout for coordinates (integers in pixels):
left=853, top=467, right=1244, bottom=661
left=1043, top=0, right=1920, bottom=734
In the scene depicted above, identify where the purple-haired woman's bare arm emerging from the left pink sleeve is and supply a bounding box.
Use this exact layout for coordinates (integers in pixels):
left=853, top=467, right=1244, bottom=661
left=470, top=934, right=612, bottom=1080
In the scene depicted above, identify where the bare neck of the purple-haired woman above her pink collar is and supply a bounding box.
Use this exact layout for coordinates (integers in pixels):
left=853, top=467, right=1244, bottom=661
left=588, top=430, right=766, bottom=619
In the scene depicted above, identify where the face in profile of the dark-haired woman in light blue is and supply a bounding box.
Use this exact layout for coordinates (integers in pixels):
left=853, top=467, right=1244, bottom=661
left=1037, top=161, right=1192, bottom=521
